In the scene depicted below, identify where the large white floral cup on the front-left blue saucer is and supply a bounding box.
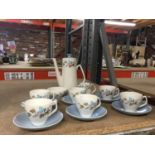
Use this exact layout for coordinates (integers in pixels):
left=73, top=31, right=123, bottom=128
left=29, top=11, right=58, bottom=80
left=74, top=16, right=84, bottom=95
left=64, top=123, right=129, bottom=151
left=21, top=98, right=58, bottom=126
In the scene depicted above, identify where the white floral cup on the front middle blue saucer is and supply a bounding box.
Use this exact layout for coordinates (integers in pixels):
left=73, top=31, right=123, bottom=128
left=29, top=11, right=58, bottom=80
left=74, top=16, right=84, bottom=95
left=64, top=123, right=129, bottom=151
left=75, top=94, right=101, bottom=118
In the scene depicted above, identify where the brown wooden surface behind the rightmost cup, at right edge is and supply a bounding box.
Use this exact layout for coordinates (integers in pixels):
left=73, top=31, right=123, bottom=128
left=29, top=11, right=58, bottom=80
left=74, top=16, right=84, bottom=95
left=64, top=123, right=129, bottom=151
left=117, top=78, right=155, bottom=98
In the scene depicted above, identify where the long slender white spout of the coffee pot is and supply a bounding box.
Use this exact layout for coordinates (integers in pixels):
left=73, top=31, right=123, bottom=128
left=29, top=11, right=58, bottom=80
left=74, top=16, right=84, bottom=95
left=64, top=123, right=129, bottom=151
left=53, top=58, right=63, bottom=87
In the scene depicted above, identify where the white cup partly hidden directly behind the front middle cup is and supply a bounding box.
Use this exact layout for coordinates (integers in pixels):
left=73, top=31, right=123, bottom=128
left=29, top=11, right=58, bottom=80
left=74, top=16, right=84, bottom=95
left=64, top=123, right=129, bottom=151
left=68, top=87, right=86, bottom=103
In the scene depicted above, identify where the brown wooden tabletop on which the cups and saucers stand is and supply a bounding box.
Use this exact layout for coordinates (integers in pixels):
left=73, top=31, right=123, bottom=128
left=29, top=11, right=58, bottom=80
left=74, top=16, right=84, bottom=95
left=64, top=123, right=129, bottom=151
left=0, top=80, right=155, bottom=135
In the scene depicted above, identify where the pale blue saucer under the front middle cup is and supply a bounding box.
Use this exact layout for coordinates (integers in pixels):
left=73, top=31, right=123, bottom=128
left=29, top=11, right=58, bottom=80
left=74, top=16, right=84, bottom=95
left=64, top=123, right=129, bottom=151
left=66, top=105, right=107, bottom=121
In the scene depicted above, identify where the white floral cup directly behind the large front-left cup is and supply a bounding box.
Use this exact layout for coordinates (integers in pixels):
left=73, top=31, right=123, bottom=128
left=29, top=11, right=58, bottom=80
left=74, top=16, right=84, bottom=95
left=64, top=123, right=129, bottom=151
left=29, top=89, right=50, bottom=98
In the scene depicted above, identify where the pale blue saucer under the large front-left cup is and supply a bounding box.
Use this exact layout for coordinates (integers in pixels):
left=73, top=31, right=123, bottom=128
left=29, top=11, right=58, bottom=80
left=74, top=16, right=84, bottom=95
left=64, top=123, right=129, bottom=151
left=13, top=111, right=63, bottom=130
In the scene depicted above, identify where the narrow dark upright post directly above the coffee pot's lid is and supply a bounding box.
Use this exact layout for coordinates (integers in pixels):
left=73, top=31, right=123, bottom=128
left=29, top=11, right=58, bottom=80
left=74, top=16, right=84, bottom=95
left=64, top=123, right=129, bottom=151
left=65, top=19, right=72, bottom=56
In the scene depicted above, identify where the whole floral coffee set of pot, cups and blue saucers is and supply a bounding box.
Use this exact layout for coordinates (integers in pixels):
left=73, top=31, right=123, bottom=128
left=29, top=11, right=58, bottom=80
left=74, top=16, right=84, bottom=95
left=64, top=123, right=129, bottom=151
left=13, top=57, right=152, bottom=130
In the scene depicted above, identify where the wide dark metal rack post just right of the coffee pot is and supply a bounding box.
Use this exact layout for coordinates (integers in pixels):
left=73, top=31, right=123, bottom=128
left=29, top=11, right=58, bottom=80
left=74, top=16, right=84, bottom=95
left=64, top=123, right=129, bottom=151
left=88, top=19, right=102, bottom=84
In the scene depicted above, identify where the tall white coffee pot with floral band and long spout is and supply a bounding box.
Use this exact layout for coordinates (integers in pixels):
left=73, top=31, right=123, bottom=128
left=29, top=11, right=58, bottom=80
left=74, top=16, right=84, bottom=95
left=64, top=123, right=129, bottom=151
left=53, top=57, right=85, bottom=89
